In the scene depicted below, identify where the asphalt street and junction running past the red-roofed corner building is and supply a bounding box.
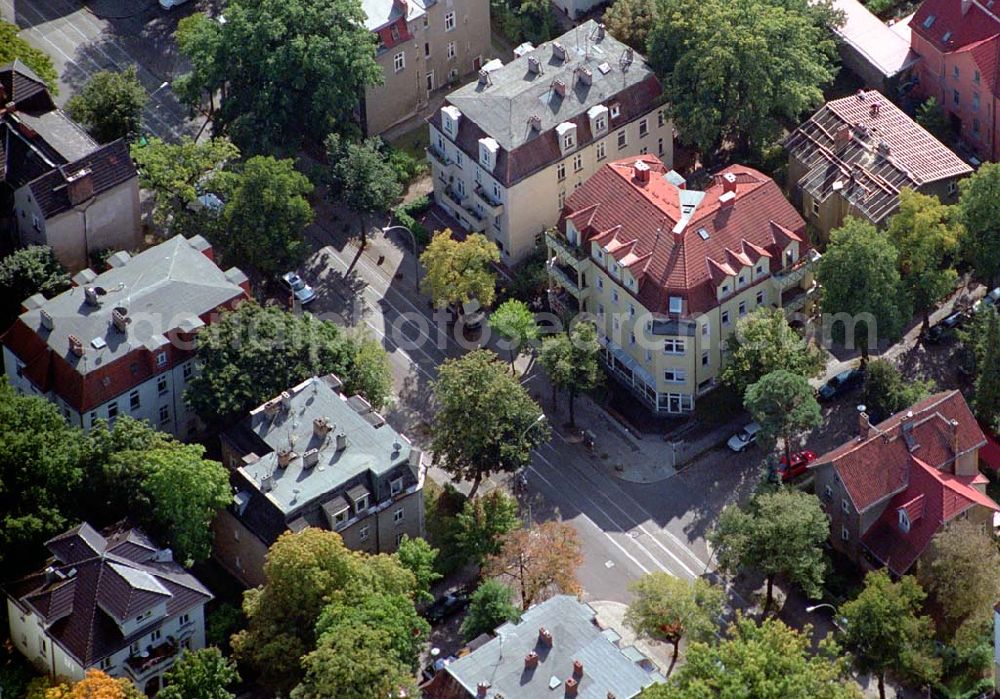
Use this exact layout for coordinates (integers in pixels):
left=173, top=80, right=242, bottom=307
left=305, top=226, right=753, bottom=602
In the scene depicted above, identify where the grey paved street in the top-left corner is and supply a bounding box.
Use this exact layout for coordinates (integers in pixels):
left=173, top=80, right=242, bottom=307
left=0, top=0, right=210, bottom=140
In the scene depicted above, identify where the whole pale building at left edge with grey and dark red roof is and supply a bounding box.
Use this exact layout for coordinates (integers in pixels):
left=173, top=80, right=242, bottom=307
left=2, top=236, right=250, bottom=438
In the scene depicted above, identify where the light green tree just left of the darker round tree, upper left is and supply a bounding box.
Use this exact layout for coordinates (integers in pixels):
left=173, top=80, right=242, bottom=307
left=132, top=138, right=240, bottom=234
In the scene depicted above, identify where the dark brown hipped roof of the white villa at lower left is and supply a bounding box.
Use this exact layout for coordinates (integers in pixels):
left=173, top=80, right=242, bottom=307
left=7, top=523, right=212, bottom=668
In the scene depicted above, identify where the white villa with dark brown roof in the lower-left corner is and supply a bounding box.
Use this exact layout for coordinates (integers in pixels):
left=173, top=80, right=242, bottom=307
left=6, top=523, right=212, bottom=696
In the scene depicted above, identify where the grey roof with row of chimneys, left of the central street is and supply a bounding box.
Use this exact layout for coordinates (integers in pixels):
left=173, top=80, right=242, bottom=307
left=223, top=375, right=421, bottom=542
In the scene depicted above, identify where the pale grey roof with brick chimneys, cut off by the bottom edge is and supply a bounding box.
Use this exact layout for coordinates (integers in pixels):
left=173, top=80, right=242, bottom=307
left=444, top=595, right=664, bottom=699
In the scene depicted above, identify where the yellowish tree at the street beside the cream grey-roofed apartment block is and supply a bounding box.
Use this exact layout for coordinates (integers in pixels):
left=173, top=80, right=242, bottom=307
left=420, top=228, right=500, bottom=308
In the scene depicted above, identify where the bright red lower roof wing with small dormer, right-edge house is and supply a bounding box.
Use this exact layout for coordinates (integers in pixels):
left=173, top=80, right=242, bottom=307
left=862, top=457, right=1000, bottom=575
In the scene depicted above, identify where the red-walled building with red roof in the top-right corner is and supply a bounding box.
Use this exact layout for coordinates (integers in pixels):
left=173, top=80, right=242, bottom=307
left=910, top=0, right=1000, bottom=160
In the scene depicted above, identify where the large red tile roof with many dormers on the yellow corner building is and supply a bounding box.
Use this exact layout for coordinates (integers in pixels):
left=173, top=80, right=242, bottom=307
left=559, top=155, right=809, bottom=314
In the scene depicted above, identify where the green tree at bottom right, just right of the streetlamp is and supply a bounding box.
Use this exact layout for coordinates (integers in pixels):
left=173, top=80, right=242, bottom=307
left=840, top=570, right=941, bottom=699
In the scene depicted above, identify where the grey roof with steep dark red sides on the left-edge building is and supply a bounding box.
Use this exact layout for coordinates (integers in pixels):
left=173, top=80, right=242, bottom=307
left=3, top=236, right=247, bottom=412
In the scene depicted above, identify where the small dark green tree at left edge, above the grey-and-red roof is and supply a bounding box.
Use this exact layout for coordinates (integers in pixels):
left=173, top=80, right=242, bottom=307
left=0, top=245, right=69, bottom=328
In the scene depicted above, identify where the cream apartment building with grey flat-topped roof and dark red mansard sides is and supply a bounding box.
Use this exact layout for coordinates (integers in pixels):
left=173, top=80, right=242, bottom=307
left=427, top=20, right=673, bottom=264
